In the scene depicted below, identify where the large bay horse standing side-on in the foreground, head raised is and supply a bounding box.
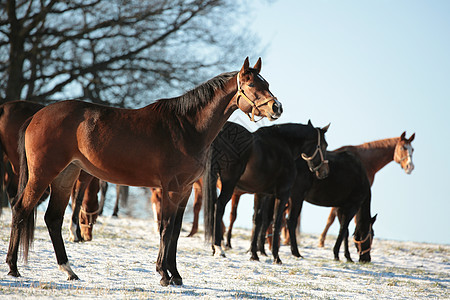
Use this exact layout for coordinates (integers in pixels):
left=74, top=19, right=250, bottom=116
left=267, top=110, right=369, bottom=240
left=6, top=58, right=282, bottom=286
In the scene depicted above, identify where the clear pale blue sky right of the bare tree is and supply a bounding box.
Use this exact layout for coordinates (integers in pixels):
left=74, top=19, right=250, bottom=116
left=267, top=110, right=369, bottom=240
left=229, top=0, right=450, bottom=244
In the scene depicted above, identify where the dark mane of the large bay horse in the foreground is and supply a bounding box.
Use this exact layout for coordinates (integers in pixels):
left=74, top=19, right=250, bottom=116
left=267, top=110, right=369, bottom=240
left=150, top=71, right=238, bottom=116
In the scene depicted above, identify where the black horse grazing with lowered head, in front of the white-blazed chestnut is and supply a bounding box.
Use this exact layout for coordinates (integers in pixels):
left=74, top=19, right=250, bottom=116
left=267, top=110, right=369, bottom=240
left=255, top=151, right=376, bottom=262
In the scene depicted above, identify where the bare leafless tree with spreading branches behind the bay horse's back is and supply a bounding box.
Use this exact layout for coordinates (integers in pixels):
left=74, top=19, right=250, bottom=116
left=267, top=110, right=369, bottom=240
left=0, top=0, right=261, bottom=107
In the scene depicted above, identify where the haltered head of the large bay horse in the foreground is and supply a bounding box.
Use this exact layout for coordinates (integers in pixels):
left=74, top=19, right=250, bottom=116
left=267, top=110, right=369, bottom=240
left=236, top=57, right=283, bottom=121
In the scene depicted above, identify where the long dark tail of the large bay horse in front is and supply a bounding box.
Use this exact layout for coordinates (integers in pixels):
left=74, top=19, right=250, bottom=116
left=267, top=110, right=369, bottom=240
left=11, top=118, right=37, bottom=262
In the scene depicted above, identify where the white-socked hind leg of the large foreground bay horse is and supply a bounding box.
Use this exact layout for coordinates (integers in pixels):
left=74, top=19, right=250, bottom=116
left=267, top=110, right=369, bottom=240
left=44, top=165, right=80, bottom=280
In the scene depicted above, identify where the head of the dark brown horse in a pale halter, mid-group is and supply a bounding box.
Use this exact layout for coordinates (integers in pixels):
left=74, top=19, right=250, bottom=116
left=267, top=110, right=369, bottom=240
left=302, top=120, right=330, bottom=179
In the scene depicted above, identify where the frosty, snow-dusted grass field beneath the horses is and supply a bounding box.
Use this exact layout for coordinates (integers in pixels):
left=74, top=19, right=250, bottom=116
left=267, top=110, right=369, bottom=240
left=0, top=209, right=450, bottom=299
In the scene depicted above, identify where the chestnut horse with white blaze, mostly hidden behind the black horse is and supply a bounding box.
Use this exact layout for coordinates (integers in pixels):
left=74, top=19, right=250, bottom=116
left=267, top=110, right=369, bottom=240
left=319, top=132, right=415, bottom=247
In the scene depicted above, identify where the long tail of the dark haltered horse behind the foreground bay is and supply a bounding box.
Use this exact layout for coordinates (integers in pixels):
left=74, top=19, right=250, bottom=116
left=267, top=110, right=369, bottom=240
left=202, top=145, right=218, bottom=242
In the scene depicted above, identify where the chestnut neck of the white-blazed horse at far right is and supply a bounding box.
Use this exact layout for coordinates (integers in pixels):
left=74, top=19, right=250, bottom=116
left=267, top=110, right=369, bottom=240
left=352, top=138, right=398, bottom=184
